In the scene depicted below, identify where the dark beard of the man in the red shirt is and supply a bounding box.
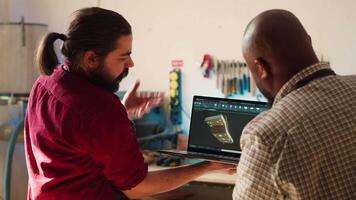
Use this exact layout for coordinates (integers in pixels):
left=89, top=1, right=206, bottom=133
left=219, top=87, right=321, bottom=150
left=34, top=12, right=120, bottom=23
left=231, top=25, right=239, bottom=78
left=89, top=65, right=129, bottom=93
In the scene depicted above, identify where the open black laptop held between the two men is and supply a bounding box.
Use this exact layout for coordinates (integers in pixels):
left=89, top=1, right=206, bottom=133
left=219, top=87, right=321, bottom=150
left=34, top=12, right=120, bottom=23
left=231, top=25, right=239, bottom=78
left=159, top=96, right=268, bottom=164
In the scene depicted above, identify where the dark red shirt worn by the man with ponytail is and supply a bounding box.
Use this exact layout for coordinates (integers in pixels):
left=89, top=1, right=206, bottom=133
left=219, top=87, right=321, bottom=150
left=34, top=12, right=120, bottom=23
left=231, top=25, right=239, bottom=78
left=25, top=66, right=147, bottom=200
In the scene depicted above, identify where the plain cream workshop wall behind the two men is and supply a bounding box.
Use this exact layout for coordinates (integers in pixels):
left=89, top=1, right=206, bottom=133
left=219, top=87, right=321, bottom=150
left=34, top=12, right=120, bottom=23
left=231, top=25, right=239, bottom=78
left=1, top=0, right=356, bottom=130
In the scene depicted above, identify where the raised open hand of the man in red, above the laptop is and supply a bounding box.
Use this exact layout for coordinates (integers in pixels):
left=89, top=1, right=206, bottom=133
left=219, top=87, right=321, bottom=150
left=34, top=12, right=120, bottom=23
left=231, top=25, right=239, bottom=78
left=122, top=81, right=163, bottom=120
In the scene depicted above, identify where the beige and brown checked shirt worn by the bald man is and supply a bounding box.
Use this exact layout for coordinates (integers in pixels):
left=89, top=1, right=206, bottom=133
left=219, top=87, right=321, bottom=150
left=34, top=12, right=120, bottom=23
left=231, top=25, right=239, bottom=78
left=233, top=63, right=356, bottom=200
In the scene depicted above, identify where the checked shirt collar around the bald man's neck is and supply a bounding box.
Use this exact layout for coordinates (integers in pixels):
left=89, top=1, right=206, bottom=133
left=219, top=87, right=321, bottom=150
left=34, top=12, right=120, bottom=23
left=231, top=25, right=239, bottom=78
left=273, top=62, right=330, bottom=106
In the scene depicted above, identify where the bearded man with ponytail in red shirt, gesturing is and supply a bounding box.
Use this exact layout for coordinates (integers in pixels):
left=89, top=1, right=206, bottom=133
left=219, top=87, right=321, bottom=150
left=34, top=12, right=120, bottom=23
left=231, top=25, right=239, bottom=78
left=25, top=8, right=235, bottom=200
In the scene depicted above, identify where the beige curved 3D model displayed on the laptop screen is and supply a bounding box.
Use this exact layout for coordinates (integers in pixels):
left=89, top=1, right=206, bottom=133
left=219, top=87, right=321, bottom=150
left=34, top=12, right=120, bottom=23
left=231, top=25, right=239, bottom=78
left=204, top=115, right=234, bottom=144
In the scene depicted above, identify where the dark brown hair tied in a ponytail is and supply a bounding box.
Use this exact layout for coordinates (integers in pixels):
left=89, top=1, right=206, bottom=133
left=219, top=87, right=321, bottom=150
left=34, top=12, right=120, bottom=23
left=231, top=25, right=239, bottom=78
left=36, top=7, right=131, bottom=75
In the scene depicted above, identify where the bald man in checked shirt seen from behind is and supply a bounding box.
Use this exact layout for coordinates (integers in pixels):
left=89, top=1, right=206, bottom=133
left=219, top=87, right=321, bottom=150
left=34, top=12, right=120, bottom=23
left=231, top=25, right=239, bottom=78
left=233, top=10, right=356, bottom=200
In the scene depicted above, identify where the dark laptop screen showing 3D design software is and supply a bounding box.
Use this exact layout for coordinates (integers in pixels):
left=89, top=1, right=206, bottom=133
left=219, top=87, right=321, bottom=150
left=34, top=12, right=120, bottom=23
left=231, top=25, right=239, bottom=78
left=189, top=98, right=267, bottom=153
